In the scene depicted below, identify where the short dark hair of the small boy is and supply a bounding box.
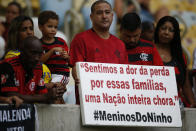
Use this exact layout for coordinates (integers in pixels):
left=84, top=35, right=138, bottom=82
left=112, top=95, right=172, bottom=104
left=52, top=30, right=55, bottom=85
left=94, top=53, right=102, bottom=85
left=38, top=11, right=59, bottom=25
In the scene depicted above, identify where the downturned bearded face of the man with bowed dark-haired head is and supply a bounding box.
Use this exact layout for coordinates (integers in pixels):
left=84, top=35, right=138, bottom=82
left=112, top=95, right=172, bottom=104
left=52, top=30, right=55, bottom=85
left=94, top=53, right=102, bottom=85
left=120, top=28, right=141, bottom=49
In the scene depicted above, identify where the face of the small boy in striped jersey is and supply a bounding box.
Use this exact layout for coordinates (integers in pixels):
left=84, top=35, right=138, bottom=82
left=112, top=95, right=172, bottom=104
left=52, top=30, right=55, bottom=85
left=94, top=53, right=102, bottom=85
left=39, top=19, right=58, bottom=38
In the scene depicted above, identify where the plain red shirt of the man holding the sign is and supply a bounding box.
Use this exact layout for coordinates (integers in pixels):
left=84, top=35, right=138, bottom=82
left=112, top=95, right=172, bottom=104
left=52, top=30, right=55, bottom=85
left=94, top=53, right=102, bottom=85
left=70, top=29, right=128, bottom=66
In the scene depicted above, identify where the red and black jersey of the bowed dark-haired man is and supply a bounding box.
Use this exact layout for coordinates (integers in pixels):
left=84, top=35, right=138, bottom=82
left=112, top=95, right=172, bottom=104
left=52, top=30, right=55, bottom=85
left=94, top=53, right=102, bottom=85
left=127, top=39, right=163, bottom=66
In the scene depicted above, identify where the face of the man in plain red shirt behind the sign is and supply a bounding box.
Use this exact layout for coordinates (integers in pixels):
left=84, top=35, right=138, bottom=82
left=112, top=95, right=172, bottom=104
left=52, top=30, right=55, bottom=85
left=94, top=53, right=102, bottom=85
left=90, top=3, right=113, bottom=30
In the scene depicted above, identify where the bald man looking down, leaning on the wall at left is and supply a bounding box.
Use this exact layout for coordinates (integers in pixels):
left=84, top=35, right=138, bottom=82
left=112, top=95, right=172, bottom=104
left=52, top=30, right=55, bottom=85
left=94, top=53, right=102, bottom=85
left=0, top=36, right=65, bottom=103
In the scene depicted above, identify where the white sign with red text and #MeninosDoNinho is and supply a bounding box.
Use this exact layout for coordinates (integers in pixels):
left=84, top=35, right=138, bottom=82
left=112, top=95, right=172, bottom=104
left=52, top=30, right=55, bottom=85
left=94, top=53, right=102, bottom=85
left=76, top=62, right=182, bottom=127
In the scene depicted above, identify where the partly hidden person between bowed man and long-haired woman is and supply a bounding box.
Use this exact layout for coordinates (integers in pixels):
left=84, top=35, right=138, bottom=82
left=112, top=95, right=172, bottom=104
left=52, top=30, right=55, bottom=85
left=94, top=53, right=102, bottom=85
left=141, top=21, right=154, bottom=42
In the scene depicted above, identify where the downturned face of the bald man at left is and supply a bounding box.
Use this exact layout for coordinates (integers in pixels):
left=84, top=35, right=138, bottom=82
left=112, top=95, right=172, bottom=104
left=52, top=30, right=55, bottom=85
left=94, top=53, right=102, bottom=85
left=21, top=40, right=42, bottom=69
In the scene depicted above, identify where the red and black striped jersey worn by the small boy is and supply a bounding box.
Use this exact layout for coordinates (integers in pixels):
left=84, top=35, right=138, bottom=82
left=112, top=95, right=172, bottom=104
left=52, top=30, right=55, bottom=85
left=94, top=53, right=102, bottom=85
left=41, top=37, right=70, bottom=76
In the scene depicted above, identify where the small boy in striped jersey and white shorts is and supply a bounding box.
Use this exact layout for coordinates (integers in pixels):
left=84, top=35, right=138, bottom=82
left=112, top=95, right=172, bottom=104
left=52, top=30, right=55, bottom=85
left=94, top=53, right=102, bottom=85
left=38, top=11, right=70, bottom=101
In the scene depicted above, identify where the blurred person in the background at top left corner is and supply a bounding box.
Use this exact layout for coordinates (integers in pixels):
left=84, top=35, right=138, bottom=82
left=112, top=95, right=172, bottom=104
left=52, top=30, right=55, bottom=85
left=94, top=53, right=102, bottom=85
left=0, top=1, right=22, bottom=42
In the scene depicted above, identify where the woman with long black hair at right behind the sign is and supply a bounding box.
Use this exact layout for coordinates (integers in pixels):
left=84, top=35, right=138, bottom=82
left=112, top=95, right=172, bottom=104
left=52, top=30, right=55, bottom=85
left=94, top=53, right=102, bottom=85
left=154, top=16, right=196, bottom=107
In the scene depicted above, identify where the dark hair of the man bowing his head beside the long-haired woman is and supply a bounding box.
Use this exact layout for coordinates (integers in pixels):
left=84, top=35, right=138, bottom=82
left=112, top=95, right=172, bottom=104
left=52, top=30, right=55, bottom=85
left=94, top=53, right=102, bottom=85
left=120, top=12, right=141, bottom=32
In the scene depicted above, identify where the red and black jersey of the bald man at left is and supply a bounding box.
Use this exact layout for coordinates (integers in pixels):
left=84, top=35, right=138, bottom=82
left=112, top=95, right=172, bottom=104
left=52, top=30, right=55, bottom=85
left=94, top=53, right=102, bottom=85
left=0, top=56, right=48, bottom=95
